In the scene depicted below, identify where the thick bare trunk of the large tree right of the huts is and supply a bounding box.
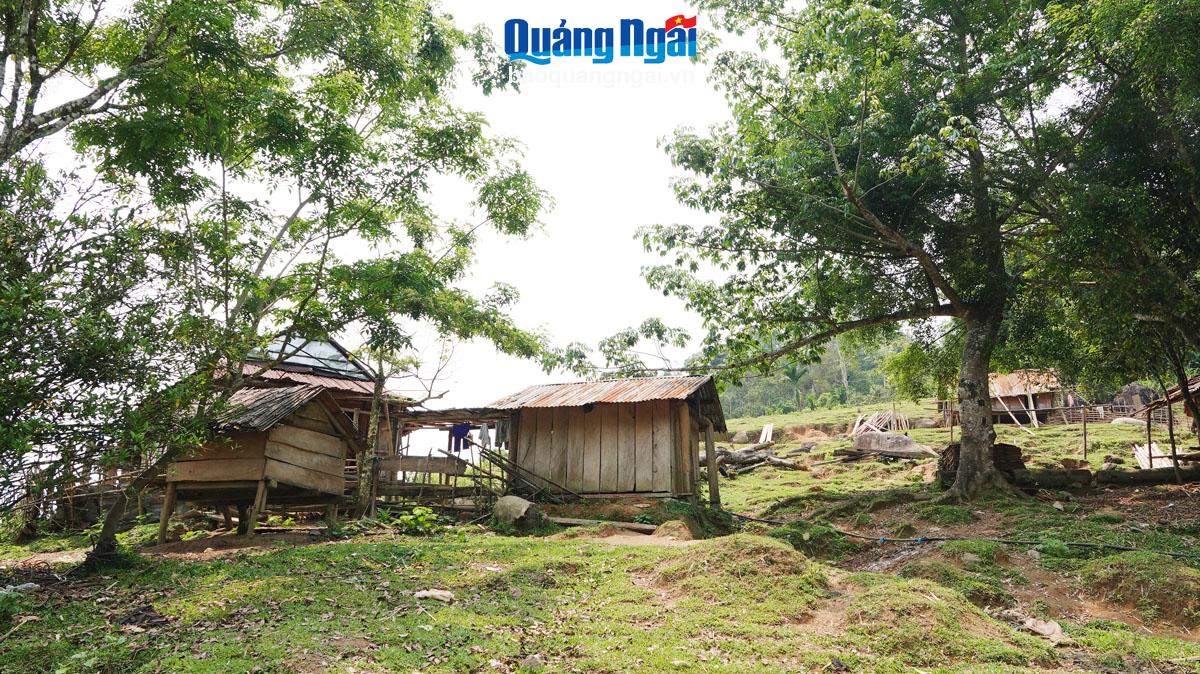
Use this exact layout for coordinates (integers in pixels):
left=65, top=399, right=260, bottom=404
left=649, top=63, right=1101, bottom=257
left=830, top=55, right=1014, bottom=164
left=948, top=311, right=1010, bottom=500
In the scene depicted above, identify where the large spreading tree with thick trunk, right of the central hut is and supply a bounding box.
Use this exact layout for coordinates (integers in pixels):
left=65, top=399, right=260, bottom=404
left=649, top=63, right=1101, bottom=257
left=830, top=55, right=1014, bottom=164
left=646, top=0, right=1111, bottom=498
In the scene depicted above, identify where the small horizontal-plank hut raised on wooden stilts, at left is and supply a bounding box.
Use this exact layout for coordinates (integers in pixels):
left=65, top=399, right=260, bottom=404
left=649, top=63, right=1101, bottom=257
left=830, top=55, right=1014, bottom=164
left=160, top=384, right=362, bottom=538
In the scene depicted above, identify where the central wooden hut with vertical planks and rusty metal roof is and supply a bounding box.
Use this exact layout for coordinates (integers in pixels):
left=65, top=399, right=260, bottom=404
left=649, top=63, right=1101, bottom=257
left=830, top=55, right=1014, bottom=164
left=488, top=377, right=726, bottom=498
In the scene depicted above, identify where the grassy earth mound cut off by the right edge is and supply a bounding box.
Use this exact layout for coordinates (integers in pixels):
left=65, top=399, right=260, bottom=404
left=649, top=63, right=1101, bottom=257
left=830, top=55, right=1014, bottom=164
left=1080, top=552, right=1200, bottom=628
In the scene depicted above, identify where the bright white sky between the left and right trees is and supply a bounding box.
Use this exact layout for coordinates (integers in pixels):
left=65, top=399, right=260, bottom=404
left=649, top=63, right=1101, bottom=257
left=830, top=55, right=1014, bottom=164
left=396, top=0, right=728, bottom=407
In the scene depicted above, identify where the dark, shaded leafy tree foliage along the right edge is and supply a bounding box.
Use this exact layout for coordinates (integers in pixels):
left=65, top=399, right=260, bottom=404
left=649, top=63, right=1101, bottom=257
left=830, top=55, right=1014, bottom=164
left=1041, top=0, right=1200, bottom=398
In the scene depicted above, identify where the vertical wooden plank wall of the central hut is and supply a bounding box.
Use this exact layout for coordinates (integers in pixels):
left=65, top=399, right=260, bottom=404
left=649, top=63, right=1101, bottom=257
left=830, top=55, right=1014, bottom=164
left=512, top=401, right=700, bottom=494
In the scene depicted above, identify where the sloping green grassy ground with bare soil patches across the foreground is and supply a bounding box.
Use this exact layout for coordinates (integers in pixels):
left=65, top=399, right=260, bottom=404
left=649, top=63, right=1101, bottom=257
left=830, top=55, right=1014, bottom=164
left=0, top=400, right=1200, bottom=674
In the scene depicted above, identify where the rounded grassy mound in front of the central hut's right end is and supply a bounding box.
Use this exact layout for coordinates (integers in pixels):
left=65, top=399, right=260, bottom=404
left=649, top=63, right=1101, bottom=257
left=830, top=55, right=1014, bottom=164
left=653, top=534, right=828, bottom=615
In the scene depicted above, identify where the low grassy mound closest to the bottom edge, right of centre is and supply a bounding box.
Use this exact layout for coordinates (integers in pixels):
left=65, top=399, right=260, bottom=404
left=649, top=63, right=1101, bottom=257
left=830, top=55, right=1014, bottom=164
left=846, top=578, right=1055, bottom=667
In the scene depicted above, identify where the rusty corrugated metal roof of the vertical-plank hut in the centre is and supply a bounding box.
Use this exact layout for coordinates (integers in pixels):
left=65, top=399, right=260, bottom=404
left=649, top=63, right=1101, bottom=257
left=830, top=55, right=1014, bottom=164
left=487, top=375, right=725, bottom=431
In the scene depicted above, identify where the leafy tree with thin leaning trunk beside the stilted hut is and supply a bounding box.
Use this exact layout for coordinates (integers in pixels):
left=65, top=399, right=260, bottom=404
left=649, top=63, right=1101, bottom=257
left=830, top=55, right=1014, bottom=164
left=5, top=0, right=546, bottom=554
